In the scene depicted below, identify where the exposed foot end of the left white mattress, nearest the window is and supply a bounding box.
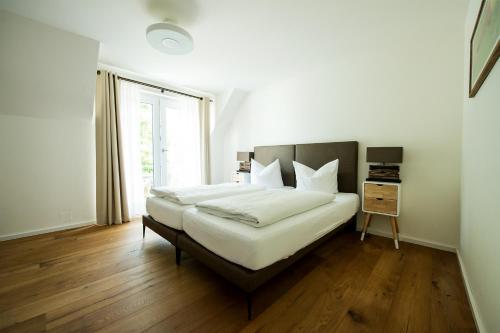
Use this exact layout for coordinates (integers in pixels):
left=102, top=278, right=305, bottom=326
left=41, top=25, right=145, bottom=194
left=146, top=197, right=194, bottom=230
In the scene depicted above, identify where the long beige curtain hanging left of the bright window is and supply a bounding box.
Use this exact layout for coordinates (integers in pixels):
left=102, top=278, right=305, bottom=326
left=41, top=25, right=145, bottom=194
left=95, top=71, right=130, bottom=225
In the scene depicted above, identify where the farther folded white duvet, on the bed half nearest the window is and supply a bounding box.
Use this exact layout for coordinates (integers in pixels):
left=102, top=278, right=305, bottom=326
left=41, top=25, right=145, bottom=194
left=151, top=183, right=265, bottom=205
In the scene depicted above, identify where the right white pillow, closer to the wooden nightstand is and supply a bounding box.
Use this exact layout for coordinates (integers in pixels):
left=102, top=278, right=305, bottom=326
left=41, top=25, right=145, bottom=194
left=293, top=159, right=339, bottom=194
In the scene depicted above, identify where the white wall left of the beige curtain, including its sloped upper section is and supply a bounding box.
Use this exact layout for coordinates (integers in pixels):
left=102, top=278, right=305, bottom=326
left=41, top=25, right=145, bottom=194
left=0, top=11, right=99, bottom=239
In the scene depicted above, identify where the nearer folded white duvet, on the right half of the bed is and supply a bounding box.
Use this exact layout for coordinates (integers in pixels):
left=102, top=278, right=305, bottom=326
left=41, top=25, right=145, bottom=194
left=196, top=189, right=335, bottom=227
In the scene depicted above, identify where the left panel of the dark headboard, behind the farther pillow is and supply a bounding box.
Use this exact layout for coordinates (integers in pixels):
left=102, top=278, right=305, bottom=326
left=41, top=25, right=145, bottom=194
left=254, top=145, right=295, bottom=186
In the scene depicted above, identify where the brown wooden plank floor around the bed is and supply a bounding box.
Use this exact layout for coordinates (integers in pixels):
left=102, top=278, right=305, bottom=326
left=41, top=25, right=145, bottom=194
left=0, top=222, right=475, bottom=332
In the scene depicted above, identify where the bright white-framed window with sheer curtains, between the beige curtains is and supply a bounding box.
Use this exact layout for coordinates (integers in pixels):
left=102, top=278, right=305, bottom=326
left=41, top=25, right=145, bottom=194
left=120, top=82, right=201, bottom=216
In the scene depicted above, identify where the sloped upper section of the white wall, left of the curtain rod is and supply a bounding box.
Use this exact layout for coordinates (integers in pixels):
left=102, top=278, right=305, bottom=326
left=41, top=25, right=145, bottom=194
left=0, top=10, right=99, bottom=120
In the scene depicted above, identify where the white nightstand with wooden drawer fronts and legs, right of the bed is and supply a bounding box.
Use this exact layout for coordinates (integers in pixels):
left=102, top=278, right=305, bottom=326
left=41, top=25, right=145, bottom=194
left=361, top=182, right=401, bottom=249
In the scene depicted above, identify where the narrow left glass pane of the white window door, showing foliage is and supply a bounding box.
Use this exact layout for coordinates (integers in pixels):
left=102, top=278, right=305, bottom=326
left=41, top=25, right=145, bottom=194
left=139, top=103, right=154, bottom=197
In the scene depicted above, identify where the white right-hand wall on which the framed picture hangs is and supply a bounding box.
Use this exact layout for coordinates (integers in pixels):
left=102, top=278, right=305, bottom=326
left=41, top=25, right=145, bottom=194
left=460, top=0, right=500, bottom=333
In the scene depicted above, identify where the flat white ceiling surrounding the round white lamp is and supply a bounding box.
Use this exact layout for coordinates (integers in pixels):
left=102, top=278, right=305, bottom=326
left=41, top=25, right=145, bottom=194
left=0, top=0, right=465, bottom=94
